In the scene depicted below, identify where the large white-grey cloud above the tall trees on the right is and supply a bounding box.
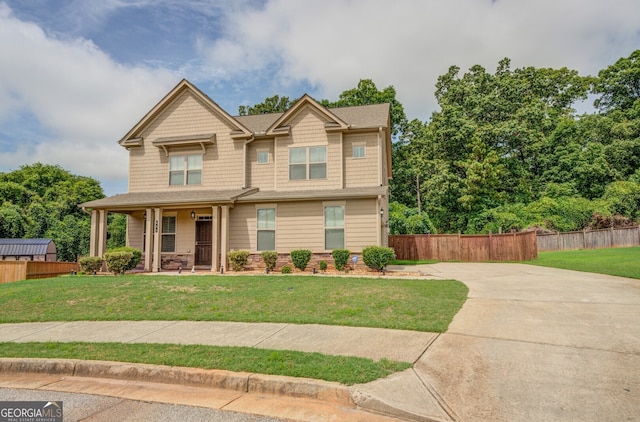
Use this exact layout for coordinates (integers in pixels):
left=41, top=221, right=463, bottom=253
left=203, top=0, right=640, bottom=120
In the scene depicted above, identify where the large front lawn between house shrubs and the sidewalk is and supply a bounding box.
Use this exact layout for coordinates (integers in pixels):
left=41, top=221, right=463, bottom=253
left=0, top=275, right=468, bottom=332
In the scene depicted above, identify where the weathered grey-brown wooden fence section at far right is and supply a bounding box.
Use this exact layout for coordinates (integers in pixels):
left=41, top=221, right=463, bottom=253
left=538, top=227, right=640, bottom=251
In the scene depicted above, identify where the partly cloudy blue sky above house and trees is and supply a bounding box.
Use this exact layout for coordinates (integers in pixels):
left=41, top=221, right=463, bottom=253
left=0, top=0, right=640, bottom=196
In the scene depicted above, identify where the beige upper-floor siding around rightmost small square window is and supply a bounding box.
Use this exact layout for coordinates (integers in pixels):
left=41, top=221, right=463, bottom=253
left=344, top=131, right=380, bottom=188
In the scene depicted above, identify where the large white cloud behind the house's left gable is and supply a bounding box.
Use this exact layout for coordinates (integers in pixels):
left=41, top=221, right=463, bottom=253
left=0, top=4, right=179, bottom=193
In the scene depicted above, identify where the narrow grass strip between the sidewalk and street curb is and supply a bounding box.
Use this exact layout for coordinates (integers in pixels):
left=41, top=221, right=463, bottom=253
left=0, top=343, right=411, bottom=385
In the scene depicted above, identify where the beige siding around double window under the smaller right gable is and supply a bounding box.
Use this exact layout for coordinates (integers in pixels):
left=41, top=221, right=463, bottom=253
left=275, top=107, right=342, bottom=191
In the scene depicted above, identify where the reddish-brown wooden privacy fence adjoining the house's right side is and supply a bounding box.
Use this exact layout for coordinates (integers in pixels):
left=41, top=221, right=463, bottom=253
left=389, top=231, right=538, bottom=262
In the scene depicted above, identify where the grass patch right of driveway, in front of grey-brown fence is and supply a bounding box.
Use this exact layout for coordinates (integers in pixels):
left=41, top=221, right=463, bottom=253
left=526, top=247, right=640, bottom=279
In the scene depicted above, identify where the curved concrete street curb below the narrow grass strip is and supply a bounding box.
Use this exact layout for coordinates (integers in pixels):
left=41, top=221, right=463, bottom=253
left=0, top=358, right=355, bottom=407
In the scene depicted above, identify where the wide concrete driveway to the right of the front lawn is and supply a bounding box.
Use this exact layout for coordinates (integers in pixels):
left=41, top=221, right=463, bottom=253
left=407, top=263, right=640, bottom=421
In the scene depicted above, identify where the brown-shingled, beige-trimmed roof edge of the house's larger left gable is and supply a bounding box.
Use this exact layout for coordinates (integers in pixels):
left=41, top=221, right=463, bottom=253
left=118, top=79, right=251, bottom=147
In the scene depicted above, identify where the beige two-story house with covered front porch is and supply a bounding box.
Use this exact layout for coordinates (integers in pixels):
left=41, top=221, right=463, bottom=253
left=81, top=80, right=391, bottom=271
